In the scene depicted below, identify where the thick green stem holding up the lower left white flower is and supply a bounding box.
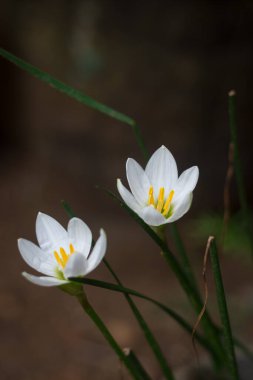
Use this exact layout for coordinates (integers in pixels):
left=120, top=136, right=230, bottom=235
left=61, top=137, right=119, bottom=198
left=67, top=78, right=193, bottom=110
left=76, top=292, right=149, bottom=380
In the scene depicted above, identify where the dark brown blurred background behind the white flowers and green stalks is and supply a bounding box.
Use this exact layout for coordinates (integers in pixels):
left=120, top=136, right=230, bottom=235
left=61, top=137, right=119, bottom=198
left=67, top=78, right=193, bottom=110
left=0, top=0, right=253, bottom=380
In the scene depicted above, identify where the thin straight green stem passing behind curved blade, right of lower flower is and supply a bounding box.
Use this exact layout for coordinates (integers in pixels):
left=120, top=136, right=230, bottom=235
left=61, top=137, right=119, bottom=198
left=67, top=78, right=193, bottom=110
left=104, top=259, right=174, bottom=380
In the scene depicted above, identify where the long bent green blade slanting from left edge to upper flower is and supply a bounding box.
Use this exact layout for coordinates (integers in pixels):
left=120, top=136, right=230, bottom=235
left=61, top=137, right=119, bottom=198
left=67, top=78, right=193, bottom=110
left=0, top=48, right=148, bottom=158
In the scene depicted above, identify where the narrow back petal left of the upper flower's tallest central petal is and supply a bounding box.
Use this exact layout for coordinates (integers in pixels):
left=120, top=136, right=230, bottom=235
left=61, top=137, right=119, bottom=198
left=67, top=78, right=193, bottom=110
left=126, top=158, right=150, bottom=205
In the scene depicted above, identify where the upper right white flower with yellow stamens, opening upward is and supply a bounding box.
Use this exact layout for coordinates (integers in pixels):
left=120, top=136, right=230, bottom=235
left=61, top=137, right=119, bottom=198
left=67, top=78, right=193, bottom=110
left=117, top=146, right=199, bottom=227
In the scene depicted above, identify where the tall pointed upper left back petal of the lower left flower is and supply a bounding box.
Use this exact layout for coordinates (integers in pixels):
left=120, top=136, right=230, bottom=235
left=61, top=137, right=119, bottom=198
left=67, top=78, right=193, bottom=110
left=36, top=212, right=69, bottom=252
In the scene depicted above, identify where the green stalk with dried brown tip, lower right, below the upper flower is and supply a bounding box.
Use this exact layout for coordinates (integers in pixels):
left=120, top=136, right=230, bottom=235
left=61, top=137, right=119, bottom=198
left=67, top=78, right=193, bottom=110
left=210, top=238, right=239, bottom=380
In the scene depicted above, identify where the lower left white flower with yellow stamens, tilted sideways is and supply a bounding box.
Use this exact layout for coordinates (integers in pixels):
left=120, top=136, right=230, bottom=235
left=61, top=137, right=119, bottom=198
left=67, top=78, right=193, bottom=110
left=18, top=212, right=106, bottom=286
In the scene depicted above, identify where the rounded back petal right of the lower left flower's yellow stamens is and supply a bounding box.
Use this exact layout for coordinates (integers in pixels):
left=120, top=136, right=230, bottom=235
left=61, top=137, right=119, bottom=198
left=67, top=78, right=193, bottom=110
left=68, top=218, right=92, bottom=258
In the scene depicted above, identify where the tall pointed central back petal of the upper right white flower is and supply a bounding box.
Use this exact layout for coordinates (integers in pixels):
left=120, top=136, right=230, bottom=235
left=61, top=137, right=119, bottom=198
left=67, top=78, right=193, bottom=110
left=145, top=145, right=178, bottom=197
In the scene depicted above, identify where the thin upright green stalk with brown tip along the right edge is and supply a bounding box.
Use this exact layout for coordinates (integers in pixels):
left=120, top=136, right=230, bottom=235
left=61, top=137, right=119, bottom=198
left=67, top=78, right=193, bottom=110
left=228, top=90, right=253, bottom=256
